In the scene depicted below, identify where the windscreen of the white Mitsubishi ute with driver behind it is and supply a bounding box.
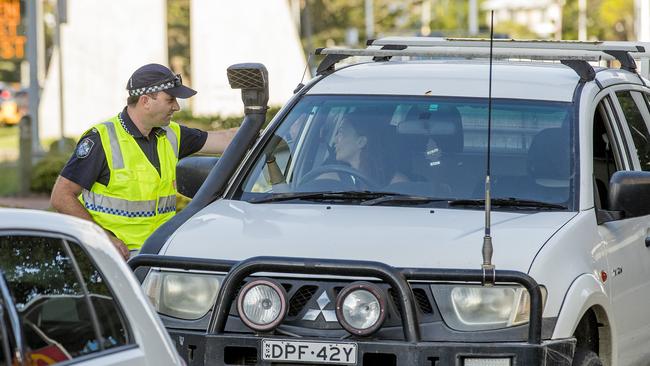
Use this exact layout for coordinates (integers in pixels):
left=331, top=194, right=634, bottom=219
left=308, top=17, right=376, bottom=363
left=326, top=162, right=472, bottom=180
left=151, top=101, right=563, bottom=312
left=237, top=96, right=575, bottom=209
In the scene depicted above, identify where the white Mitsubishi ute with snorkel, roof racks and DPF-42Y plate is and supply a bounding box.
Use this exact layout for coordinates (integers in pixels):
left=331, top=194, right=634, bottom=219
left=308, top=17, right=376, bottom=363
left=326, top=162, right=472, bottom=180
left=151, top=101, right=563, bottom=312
left=131, top=38, right=650, bottom=366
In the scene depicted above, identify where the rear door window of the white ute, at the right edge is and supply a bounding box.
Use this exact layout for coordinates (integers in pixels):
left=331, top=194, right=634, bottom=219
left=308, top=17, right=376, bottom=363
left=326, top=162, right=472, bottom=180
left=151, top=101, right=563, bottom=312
left=616, top=91, right=650, bottom=171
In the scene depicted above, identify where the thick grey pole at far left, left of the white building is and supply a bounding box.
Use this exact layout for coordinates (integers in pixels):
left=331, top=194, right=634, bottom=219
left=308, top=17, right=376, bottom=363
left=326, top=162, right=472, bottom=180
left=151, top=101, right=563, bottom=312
left=27, top=0, right=43, bottom=155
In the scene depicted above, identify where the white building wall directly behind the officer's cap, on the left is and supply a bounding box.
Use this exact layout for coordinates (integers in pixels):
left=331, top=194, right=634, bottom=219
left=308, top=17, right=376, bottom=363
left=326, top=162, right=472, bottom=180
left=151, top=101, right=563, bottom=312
left=39, top=0, right=167, bottom=138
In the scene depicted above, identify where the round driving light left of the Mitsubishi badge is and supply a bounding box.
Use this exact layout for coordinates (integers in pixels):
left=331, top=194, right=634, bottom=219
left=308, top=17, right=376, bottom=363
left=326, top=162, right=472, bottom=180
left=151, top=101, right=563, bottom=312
left=237, top=279, right=287, bottom=332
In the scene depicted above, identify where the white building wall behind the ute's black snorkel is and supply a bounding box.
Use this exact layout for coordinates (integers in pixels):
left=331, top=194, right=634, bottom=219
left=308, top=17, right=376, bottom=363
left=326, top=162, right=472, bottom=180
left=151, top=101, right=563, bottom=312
left=190, top=0, right=309, bottom=115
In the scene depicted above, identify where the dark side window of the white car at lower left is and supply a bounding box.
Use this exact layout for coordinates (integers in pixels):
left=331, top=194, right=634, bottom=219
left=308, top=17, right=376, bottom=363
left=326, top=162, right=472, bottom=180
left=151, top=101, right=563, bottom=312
left=0, top=235, right=129, bottom=362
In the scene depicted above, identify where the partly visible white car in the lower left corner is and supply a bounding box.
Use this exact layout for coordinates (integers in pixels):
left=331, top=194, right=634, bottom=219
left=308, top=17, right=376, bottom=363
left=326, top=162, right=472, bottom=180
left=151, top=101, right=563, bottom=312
left=0, top=209, right=184, bottom=366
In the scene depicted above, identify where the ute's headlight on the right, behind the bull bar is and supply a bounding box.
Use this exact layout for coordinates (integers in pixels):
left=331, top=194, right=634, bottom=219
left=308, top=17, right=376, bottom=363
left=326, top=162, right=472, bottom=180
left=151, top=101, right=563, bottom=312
left=431, top=285, right=546, bottom=330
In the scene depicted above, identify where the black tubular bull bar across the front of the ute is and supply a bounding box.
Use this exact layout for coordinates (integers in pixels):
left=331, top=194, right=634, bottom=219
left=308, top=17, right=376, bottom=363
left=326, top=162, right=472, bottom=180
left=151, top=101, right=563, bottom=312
left=128, top=254, right=543, bottom=345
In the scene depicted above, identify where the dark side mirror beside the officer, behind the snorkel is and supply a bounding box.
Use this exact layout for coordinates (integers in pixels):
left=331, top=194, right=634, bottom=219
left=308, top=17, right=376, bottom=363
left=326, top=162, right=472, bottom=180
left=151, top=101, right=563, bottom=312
left=176, top=156, right=219, bottom=198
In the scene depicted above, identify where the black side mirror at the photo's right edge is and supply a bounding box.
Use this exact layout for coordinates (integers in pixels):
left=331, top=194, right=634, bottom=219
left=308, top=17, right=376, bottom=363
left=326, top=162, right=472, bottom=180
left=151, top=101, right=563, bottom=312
left=609, top=170, right=650, bottom=218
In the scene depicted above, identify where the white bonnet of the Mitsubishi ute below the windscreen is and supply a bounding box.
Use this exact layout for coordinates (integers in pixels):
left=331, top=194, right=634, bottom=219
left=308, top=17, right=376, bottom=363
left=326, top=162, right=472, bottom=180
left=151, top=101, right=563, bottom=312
left=161, top=200, right=576, bottom=272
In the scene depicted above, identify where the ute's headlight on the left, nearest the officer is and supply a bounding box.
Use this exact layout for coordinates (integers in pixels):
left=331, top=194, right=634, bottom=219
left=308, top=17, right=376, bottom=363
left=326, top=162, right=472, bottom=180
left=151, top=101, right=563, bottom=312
left=142, top=270, right=223, bottom=320
